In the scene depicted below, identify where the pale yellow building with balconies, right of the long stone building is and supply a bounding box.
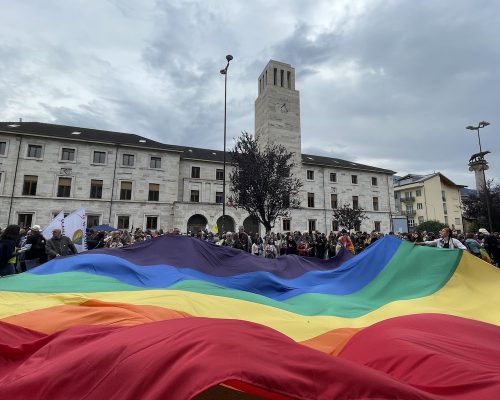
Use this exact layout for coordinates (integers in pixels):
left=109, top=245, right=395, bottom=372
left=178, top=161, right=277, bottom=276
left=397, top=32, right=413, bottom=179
left=394, top=173, right=464, bottom=232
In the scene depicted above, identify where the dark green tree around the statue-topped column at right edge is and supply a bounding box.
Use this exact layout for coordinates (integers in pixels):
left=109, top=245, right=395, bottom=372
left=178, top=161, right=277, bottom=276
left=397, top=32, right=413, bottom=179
left=462, top=180, right=500, bottom=232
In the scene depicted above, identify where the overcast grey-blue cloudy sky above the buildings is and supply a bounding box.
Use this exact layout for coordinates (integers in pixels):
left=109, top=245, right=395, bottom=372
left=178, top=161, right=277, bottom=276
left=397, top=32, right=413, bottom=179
left=0, top=0, right=500, bottom=187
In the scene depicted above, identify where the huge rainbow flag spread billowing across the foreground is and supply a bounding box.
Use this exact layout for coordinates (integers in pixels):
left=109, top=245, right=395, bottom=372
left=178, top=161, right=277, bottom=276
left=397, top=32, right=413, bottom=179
left=0, top=237, right=500, bottom=400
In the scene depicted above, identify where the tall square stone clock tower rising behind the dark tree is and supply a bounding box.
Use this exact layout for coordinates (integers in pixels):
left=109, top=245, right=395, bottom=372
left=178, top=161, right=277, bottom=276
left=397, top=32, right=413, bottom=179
left=255, top=60, right=301, bottom=172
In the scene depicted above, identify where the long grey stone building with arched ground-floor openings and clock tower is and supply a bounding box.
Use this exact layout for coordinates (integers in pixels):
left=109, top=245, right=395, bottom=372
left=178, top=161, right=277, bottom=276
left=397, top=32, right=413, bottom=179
left=0, top=61, right=394, bottom=232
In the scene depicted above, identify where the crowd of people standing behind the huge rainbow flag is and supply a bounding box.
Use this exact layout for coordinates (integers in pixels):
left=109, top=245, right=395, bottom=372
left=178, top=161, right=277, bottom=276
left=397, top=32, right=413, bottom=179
left=0, top=225, right=500, bottom=276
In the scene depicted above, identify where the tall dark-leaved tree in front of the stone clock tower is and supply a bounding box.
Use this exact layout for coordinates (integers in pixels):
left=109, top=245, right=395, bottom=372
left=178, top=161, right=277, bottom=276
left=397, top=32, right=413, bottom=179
left=229, top=132, right=302, bottom=232
